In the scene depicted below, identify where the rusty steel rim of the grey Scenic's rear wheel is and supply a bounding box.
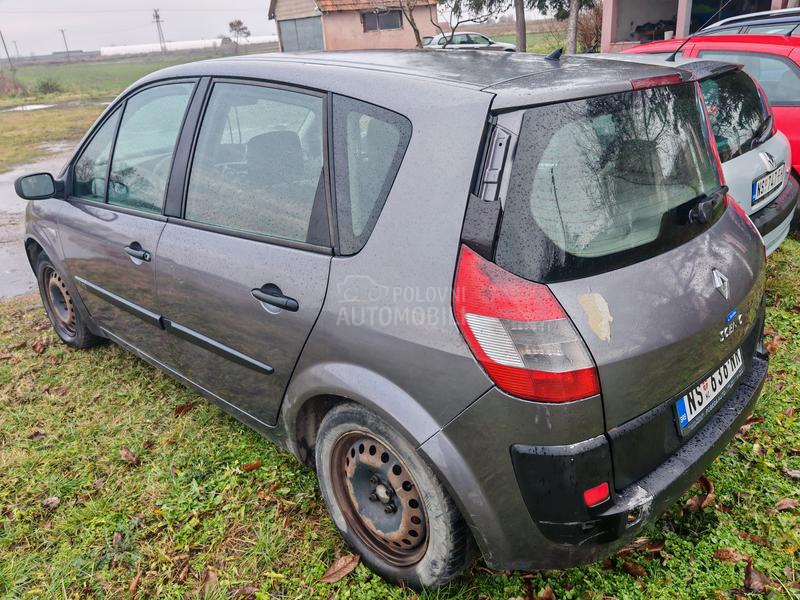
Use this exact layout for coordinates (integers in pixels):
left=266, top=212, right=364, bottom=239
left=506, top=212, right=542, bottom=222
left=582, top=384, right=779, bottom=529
left=331, top=431, right=428, bottom=567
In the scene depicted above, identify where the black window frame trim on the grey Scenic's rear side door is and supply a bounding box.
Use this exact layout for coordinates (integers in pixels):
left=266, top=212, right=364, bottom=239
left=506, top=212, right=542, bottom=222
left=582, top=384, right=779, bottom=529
left=175, top=77, right=334, bottom=255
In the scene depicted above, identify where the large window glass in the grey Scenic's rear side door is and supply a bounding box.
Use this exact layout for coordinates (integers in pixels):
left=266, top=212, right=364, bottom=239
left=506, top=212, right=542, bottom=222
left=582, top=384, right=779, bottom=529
left=185, top=83, right=330, bottom=245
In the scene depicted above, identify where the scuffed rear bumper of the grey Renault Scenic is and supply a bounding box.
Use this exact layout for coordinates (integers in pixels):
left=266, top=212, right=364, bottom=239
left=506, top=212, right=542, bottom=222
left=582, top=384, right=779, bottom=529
left=419, top=325, right=768, bottom=570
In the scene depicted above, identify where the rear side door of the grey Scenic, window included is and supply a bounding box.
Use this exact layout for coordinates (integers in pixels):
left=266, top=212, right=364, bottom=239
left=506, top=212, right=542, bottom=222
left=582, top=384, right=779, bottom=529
left=156, top=80, right=332, bottom=424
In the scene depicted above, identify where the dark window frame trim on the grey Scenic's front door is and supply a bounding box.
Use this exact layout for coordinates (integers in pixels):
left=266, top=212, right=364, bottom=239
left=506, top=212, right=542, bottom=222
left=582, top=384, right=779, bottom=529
left=64, top=77, right=202, bottom=221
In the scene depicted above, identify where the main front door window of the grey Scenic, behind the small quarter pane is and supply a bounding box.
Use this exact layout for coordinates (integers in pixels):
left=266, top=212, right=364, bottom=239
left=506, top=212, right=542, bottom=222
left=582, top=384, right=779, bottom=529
left=108, top=83, right=194, bottom=213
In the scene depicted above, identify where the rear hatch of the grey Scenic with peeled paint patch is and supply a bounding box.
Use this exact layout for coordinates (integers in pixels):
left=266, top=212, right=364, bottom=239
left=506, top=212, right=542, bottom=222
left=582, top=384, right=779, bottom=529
left=482, top=80, right=765, bottom=489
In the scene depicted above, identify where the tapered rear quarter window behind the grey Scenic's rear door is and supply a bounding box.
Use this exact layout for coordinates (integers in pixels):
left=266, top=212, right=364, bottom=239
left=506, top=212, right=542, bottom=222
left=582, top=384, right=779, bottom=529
left=333, top=96, right=411, bottom=254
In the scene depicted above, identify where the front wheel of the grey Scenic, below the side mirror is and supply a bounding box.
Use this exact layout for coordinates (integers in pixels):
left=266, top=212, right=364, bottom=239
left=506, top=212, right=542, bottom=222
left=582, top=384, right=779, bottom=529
left=35, top=253, right=104, bottom=349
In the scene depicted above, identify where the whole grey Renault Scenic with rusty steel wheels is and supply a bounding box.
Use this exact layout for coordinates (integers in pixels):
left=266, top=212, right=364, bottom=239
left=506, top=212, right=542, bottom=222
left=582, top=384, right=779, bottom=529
left=17, top=52, right=767, bottom=588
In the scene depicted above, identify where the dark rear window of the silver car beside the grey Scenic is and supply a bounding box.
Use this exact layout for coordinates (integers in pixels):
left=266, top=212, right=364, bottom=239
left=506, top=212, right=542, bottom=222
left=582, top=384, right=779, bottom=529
left=700, top=71, right=769, bottom=162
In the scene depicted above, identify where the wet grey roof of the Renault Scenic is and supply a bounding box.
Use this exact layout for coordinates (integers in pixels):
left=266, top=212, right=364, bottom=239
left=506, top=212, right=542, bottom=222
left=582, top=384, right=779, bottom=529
left=141, top=50, right=690, bottom=109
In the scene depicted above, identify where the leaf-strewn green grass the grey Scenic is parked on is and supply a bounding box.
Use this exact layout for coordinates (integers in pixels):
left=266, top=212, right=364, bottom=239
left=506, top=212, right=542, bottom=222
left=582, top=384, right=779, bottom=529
left=0, top=240, right=800, bottom=600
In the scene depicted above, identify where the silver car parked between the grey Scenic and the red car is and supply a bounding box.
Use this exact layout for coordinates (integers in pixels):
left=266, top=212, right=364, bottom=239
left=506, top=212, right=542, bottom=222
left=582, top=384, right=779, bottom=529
left=605, top=54, right=798, bottom=256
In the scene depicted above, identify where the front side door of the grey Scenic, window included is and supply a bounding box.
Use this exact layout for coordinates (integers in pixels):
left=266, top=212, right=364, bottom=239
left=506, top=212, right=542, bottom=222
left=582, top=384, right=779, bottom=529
left=59, top=81, right=196, bottom=353
